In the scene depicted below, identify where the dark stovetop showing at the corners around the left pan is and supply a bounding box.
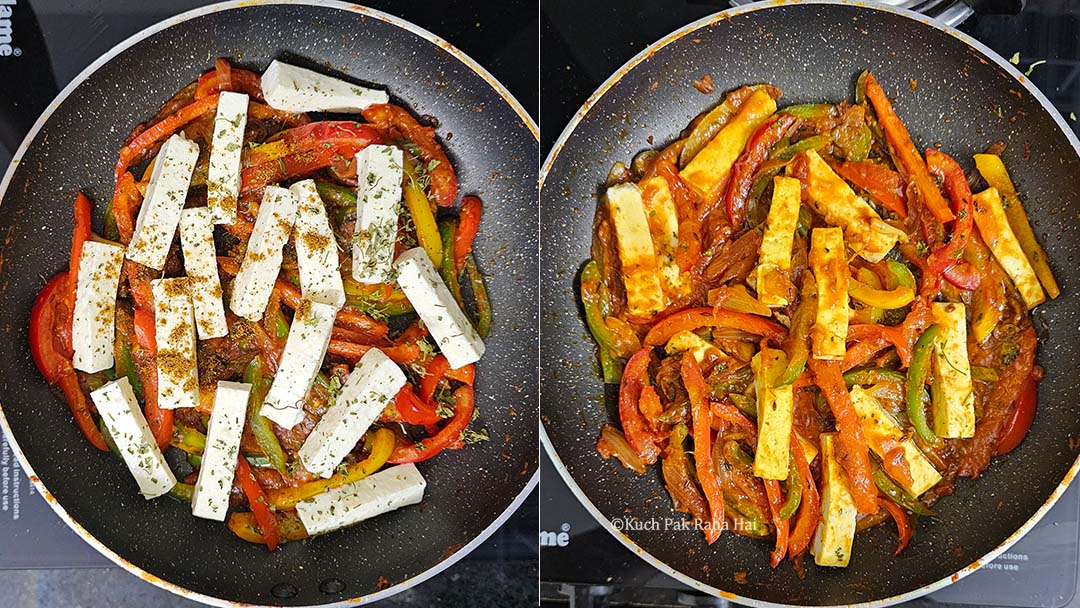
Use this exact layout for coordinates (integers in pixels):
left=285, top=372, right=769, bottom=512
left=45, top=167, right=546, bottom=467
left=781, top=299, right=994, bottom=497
left=0, top=0, right=539, bottom=578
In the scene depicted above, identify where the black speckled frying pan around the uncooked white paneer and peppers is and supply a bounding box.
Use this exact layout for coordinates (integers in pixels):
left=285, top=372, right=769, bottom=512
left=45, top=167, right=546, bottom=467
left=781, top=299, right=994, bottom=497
left=0, top=2, right=537, bottom=606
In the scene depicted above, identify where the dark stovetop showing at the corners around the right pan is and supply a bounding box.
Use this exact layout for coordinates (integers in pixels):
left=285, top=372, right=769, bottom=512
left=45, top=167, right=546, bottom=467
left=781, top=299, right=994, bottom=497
left=540, top=0, right=1080, bottom=608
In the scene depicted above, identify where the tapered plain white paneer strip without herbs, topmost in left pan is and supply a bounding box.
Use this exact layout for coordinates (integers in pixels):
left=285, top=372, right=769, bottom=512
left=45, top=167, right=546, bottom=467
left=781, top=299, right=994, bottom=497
left=261, top=60, right=390, bottom=113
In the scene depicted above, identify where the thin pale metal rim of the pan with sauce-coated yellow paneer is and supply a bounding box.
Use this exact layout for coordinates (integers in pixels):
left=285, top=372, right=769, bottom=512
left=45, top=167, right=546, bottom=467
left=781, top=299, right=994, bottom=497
left=540, top=0, right=1080, bottom=608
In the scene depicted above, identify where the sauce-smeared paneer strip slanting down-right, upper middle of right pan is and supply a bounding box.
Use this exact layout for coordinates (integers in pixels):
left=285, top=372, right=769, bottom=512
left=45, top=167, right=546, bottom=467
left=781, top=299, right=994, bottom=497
left=806, top=150, right=907, bottom=262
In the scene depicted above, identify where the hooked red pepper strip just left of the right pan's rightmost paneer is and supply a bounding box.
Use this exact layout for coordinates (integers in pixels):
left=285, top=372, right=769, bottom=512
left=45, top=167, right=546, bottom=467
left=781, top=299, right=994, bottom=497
left=927, top=148, right=978, bottom=289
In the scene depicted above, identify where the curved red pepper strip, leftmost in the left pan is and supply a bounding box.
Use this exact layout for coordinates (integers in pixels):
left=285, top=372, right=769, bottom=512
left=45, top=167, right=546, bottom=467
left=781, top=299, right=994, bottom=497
left=30, top=272, right=109, bottom=451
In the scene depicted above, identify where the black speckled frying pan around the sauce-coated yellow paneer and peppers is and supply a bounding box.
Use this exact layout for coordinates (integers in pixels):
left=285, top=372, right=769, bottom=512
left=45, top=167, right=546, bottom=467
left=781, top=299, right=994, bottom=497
left=541, top=0, right=1080, bottom=606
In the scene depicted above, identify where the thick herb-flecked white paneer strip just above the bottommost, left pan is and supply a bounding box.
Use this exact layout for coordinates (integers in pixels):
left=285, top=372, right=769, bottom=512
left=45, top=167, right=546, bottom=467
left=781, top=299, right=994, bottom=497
left=298, top=348, right=406, bottom=477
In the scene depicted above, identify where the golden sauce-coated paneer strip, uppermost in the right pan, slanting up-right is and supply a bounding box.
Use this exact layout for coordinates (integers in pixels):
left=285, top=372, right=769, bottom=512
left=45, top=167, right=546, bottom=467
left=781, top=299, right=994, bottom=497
left=679, top=90, right=777, bottom=195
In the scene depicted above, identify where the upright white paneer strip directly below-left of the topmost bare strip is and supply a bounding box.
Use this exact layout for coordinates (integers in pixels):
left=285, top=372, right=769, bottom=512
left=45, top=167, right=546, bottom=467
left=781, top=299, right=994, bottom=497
left=206, top=91, right=247, bottom=224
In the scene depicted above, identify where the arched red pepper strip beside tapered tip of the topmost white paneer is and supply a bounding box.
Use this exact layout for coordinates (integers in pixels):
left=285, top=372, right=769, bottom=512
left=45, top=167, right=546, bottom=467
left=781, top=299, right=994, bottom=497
left=361, top=104, right=458, bottom=207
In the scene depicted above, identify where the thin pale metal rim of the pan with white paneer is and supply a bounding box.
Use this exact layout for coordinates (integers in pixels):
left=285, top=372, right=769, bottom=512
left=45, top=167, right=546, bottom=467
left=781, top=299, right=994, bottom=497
left=0, top=0, right=540, bottom=608
